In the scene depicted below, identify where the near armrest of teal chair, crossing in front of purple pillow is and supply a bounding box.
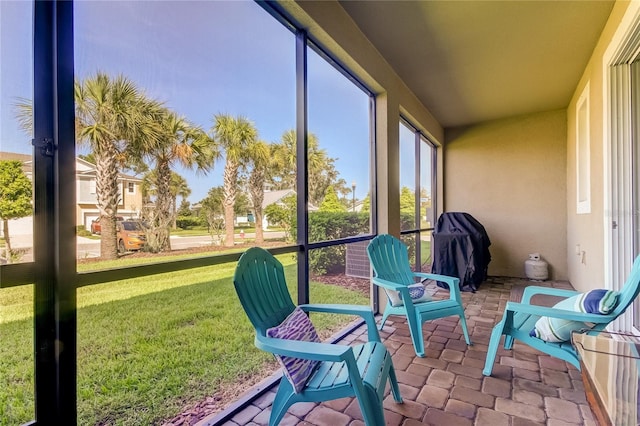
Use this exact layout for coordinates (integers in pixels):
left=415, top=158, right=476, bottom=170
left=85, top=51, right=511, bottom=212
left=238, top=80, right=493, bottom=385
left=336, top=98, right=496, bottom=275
left=254, top=334, right=353, bottom=362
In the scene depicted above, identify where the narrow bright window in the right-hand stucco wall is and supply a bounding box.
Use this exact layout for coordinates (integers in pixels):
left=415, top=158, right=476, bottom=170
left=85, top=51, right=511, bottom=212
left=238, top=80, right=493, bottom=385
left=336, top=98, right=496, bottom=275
left=576, top=83, right=591, bottom=214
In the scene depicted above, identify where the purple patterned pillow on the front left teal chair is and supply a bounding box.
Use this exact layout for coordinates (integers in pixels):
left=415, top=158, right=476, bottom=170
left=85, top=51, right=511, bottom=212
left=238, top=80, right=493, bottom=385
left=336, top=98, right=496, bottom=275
left=267, top=308, right=320, bottom=392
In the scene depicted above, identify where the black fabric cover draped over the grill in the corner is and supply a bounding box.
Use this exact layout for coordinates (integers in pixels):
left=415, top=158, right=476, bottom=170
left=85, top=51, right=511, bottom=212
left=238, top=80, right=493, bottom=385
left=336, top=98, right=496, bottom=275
left=431, top=212, right=491, bottom=291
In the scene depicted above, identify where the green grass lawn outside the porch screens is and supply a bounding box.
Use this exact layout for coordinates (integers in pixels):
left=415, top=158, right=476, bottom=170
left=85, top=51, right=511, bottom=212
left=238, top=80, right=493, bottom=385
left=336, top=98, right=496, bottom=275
left=0, top=255, right=368, bottom=425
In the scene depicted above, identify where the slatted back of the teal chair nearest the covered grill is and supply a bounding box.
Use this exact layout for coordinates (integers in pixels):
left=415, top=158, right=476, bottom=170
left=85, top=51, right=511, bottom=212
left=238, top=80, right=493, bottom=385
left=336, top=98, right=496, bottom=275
left=367, top=234, right=415, bottom=285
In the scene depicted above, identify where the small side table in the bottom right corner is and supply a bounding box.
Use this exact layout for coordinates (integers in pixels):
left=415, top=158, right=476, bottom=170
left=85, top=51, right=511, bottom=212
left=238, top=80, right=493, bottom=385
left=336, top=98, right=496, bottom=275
left=572, top=333, right=640, bottom=426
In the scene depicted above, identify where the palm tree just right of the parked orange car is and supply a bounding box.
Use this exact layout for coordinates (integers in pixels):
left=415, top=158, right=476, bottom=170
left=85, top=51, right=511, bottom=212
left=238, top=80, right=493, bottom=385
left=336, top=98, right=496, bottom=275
left=141, top=110, right=218, bottom=251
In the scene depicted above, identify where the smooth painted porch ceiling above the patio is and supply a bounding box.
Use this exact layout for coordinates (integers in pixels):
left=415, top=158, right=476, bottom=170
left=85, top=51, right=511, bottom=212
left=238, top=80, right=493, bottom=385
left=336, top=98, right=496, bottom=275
left=340, top=0, right=614, bottom=127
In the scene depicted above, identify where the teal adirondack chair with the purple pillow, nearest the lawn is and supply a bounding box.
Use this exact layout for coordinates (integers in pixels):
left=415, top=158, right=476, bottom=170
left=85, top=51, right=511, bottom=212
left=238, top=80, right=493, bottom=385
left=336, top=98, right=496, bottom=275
left=233, top=247, right=402, bottom=426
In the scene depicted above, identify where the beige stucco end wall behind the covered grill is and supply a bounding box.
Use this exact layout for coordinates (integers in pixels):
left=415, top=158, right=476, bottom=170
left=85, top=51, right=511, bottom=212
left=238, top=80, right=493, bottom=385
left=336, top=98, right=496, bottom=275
left=444, top=110, right=568, bottom=279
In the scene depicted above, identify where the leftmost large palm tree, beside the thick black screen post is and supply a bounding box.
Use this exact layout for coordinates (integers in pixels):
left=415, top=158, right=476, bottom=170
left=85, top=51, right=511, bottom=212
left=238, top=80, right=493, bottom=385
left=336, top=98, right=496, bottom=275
left=75, top=72, right=164, bottom=259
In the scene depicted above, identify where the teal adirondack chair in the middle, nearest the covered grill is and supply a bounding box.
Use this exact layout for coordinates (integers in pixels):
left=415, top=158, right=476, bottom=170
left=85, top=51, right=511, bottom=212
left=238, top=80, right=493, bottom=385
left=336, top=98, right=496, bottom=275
left=367, top=234, right=471, bottom=357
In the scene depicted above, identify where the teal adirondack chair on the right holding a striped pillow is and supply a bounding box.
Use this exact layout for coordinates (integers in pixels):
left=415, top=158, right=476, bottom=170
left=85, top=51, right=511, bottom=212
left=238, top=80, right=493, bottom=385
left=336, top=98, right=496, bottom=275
left=482, top=256, right=640, bottom=376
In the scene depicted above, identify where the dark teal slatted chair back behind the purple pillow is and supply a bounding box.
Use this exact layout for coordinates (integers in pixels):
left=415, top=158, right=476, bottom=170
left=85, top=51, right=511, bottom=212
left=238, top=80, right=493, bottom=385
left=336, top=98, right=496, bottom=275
left=233, top=247, right=295, bottom=336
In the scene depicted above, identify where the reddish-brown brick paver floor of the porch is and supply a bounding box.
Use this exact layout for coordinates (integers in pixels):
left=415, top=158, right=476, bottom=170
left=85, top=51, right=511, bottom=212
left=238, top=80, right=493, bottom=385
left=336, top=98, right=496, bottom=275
left=199, top=277, right=596, bottom=426
